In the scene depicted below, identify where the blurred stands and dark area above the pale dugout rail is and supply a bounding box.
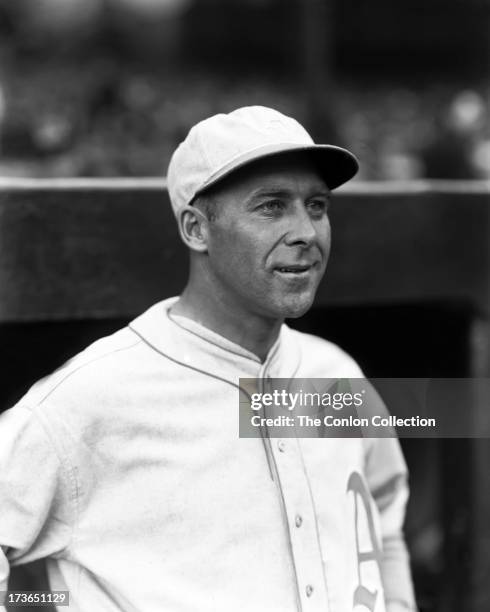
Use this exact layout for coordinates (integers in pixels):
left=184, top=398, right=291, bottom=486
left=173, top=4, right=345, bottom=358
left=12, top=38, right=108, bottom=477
left=0, top=0, right=490, bottom=180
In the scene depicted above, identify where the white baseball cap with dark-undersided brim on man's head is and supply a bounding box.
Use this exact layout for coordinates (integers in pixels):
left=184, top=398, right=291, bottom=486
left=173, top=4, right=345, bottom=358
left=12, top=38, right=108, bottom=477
left=167, top=106, right=359, bottom=215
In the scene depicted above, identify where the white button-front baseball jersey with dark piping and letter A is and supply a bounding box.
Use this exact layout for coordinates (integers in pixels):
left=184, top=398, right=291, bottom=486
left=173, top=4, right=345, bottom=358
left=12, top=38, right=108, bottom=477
left=0, top=298, right=413, bottom=612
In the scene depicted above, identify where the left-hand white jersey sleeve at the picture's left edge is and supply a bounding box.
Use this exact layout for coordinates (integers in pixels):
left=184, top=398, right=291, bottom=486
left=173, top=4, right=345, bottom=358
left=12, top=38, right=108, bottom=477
left=0, top=405, right=75, bottom=596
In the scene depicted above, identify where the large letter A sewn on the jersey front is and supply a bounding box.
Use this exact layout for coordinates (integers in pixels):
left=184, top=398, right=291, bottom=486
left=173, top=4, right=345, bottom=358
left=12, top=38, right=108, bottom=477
left=347, top=472, right=382, bottom=612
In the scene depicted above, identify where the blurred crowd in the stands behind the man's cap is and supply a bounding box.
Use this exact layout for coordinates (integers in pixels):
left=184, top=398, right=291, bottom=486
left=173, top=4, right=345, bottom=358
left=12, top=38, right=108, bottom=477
left=0, top=0, right=490, bottom=180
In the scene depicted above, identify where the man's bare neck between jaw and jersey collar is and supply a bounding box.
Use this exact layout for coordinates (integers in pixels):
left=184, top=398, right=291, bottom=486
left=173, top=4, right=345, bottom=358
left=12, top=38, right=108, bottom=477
left=171, top=286, right=282, bottom=361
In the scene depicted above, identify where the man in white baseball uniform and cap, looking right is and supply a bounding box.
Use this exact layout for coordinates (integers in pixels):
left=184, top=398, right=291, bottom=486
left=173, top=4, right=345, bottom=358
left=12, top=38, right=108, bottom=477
left=0, top=107, right=415, bottom=612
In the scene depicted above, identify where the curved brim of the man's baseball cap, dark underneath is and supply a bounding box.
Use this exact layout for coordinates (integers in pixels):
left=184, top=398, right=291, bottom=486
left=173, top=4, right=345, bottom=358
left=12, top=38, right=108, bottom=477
left=194, top=143, right=359, bottom=197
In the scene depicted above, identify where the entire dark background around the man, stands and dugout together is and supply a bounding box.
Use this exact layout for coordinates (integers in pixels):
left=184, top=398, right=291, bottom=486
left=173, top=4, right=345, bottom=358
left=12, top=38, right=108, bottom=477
left=0, top=0, right=490, bottom=612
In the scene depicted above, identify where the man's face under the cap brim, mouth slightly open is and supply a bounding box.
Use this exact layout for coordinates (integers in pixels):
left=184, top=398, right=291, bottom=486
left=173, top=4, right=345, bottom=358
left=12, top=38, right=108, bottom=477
left=201, top=156, right=330, bottom=320
